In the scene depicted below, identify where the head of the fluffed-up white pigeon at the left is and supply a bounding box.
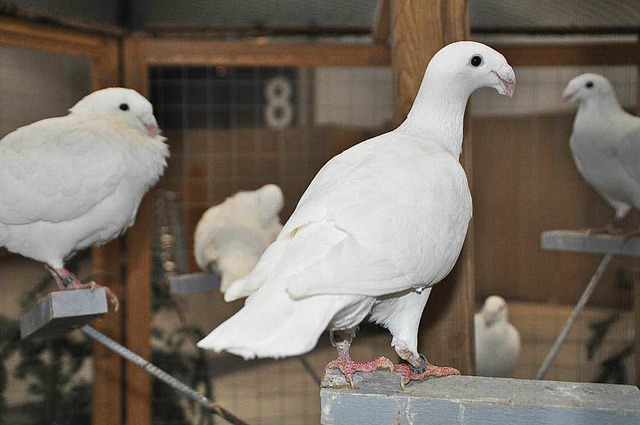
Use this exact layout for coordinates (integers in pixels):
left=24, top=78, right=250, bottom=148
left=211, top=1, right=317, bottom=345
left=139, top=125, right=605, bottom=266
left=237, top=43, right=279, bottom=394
left=69, top=87, right=160, bottom=137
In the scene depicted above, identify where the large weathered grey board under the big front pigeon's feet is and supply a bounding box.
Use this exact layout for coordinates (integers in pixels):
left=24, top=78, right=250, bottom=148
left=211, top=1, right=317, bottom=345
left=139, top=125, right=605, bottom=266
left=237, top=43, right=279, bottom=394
left=320, top=371, right=640, bottom=425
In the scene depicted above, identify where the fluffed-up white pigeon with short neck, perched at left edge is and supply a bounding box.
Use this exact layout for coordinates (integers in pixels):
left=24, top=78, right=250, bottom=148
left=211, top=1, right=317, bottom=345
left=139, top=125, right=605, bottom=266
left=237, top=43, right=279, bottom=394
left=0, top=87, right=169, bottom=309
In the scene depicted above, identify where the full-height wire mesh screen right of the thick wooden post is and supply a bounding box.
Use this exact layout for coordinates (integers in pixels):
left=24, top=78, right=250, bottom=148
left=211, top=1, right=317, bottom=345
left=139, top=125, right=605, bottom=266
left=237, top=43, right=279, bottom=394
left=471, top=61, right=638, bottom=383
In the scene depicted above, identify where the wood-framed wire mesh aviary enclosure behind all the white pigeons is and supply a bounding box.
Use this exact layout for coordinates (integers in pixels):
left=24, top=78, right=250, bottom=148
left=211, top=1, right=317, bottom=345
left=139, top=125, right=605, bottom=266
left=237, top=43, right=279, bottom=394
left=0, top=0, right=640, bottom=425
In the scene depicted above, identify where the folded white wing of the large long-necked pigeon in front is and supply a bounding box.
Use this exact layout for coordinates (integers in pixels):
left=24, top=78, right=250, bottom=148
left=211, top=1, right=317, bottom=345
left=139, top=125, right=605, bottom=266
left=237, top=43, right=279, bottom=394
left=262, top=132, right=471, bottom=298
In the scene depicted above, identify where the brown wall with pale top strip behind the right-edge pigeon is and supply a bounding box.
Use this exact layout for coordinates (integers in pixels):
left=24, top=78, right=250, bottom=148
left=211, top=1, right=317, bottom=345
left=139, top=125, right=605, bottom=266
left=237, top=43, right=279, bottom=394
left=471, top=66, right=638, bottom=307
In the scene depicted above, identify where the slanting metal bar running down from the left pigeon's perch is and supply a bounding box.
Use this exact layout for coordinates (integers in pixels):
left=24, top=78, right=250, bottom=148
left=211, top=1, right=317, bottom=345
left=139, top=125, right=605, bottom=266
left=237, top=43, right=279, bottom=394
left=81, top=325, right=248, bottom=425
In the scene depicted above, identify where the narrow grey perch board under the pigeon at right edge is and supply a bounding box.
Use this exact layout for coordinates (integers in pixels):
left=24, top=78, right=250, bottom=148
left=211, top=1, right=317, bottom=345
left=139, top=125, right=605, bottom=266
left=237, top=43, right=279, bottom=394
left=540, top=230, right=640, bottom=256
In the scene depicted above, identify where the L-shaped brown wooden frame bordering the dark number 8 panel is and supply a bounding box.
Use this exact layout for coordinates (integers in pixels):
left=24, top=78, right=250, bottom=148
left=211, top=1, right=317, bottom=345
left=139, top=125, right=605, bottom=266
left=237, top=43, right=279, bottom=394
left=123, top=35, right=391, bottom=423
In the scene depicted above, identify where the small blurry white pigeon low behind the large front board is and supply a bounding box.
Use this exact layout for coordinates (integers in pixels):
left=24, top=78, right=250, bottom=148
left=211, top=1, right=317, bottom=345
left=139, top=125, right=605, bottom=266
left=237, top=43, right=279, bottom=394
left=474, top=295, right=520, bottom=377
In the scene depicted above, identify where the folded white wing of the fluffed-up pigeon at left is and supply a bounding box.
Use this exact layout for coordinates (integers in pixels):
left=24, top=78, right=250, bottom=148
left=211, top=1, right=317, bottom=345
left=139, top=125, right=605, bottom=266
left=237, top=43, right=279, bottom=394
left=0, top=115, right=124, bottom=224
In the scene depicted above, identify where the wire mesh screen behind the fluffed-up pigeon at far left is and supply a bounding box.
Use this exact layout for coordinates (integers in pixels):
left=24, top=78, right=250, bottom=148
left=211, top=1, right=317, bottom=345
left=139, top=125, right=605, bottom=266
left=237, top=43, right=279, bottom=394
left=0, top=46, right=93, bottom=425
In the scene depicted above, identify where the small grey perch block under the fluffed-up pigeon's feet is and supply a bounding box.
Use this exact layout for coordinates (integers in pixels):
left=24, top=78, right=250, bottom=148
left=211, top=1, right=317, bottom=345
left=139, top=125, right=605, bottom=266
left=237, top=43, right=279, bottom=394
left=20, top=288, right=108, bottom=339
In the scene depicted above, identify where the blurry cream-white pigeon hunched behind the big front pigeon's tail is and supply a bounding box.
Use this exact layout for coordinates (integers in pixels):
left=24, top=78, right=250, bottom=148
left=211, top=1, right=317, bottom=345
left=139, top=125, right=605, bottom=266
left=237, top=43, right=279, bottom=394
left=193, top=184, right=284, bottom=292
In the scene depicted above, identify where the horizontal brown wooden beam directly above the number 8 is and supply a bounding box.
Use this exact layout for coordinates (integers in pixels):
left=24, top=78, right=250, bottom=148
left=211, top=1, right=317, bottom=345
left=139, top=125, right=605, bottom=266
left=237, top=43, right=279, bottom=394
left=121, top=35, right=391, bottom=67
